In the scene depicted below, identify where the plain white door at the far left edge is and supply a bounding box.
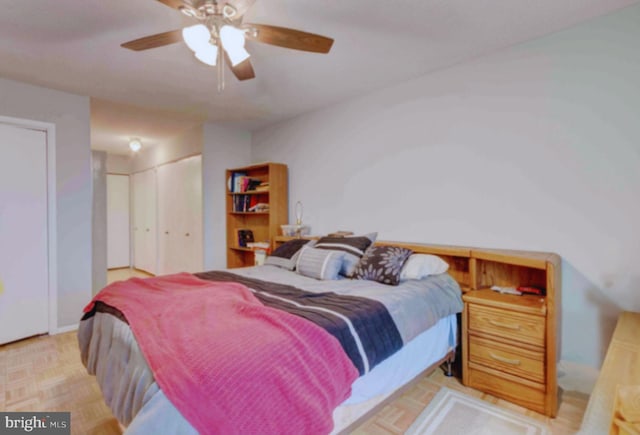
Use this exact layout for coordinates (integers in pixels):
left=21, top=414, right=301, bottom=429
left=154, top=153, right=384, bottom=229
left=0, top=124, right=49, bottom=344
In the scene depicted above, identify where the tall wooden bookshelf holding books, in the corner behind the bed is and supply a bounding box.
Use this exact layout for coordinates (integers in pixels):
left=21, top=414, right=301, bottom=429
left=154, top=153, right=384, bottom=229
left=225, top=163, right=289, bottom=268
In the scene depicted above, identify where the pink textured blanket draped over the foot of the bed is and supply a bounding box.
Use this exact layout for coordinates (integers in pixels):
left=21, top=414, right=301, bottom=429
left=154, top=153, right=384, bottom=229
left=84, top=273, right=358, bottom=434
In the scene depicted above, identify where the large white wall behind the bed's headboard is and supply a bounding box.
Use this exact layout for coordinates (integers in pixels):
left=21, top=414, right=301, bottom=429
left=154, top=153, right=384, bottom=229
left=252, top=7, right=640, bottom=366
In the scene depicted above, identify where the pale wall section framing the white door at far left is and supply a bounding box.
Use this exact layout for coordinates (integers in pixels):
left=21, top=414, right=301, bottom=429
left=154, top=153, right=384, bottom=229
left=0, top=78, right=92, bottom=327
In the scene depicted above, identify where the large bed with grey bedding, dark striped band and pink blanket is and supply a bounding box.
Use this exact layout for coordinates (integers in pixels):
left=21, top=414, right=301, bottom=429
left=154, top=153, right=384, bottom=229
left=78, top=238, right=462, bottom=435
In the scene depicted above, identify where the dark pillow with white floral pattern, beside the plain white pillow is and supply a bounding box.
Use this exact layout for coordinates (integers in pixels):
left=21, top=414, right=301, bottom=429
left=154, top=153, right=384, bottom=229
left=353, top=246, right=413, bottom=285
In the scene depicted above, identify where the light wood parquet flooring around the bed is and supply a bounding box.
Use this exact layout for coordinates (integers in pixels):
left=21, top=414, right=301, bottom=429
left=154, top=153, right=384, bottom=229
left=0, top=272, right=588, bottom=435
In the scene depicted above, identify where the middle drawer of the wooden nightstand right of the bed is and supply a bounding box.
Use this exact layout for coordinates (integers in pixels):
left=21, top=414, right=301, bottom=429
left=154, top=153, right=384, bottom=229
left=469, top=335, right=544, bottom=383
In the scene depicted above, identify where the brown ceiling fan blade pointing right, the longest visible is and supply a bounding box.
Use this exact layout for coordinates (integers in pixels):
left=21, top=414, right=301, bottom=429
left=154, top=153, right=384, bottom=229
left=243, top=24, right=333, bottom=53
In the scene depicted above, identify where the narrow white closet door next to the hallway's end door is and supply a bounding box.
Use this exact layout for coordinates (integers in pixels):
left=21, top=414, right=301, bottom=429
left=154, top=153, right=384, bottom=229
left=132, top=169, right=158, bottom=274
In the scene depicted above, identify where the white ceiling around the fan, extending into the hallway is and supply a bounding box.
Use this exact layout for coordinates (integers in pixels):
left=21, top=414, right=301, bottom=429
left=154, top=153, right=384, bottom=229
left=0, top=0, right=640, bottom=156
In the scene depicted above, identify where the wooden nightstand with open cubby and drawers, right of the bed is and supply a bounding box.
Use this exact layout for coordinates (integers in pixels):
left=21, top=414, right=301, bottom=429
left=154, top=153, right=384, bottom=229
left=462, top=250, right=560, bottom=417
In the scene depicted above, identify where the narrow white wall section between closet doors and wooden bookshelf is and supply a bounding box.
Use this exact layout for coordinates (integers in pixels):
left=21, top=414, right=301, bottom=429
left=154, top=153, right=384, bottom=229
left=202, top=124, right=251, bottom=270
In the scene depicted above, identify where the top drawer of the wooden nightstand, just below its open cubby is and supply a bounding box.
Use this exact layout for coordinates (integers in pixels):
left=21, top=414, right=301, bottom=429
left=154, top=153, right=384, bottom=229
left=468, top=304, right=545, bottom=347
